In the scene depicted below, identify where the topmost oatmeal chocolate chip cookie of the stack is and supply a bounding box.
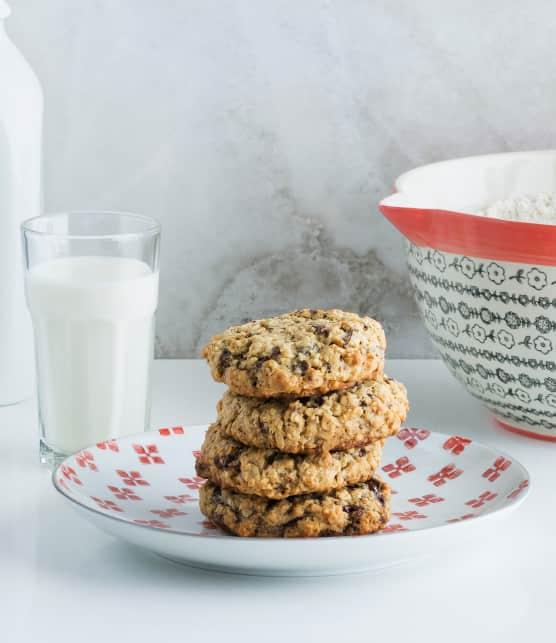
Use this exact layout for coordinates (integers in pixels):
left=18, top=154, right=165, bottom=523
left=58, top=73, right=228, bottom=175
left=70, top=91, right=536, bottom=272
left=202, top=310, right=386, bottom=397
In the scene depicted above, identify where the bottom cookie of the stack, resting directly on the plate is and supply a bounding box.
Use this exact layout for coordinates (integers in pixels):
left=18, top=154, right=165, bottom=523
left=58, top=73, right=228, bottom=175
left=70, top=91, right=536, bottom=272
left=199, top=478, right=390, bottom=538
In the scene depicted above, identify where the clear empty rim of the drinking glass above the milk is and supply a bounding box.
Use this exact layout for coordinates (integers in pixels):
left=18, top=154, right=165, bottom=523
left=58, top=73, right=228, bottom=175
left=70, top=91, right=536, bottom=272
left=21, top=210, right=161, bottom=239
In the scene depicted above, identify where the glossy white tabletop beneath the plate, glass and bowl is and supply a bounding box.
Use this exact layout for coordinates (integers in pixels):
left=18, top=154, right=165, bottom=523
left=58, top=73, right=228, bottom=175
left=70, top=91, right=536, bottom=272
left=0, top=360, right=556, bottom=643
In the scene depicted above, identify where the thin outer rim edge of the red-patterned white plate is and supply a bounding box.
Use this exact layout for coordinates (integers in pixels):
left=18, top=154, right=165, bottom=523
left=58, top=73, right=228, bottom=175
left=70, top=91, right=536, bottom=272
left=50, top=423, right=532, bottom=547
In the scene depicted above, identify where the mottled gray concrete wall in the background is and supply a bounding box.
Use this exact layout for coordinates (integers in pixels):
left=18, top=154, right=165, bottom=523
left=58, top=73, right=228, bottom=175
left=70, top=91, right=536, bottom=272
left=8, top=0, right=556, bottom=357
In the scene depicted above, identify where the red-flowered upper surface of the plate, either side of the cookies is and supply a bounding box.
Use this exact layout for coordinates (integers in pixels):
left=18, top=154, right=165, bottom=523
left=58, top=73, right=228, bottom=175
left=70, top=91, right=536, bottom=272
left=54, top=427, right=529, bottom=538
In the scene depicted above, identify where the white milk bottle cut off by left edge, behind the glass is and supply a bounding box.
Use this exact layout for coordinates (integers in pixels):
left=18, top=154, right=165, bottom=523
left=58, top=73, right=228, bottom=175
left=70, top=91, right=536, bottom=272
left=0, top=0, right=43, bottom=406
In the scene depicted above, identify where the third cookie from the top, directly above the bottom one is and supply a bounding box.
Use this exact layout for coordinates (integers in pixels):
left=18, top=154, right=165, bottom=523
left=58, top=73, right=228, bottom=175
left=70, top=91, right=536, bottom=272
left=195, top=424, right=382, bottom=499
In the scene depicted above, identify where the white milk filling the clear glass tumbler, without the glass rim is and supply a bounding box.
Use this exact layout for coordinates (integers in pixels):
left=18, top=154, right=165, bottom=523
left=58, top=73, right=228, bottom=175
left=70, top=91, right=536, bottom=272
left=26, top=257, right=158, bottom=453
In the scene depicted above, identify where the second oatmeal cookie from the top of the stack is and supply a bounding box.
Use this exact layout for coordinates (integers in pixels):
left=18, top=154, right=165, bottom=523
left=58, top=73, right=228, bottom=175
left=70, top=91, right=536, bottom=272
left=217, top=377, right=408, bottom=453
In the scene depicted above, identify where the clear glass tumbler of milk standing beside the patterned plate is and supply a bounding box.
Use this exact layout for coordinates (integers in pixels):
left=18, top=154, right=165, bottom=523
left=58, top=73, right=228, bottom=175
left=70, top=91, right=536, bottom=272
left=22, top=212, right=160, bottom=466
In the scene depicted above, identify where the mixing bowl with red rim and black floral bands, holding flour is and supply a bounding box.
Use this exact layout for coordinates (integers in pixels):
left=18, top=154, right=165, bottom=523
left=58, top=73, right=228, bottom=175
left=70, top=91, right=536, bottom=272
left=380, top=150, right=556, bottom=441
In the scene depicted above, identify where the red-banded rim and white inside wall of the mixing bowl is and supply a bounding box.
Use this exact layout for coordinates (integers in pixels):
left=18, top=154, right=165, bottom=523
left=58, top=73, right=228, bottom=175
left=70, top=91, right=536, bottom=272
left=379, top=150, right=556, bottom=266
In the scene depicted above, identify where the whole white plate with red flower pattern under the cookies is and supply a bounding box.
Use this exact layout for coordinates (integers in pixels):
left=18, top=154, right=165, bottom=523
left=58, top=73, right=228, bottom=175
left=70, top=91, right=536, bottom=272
left=53, top=425, right=529, bottom=576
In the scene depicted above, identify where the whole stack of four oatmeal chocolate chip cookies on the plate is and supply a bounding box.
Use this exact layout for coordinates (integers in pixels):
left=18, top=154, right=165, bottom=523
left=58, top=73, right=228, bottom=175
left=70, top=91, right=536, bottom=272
left=197, top=310, right=408, bottom=537
